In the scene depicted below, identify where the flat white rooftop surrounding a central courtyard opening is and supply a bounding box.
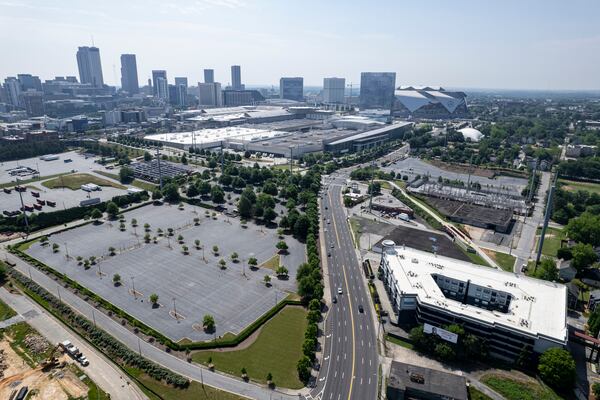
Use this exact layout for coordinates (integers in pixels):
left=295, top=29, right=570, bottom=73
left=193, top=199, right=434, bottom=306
left=385, top=246, right=568, bottom=344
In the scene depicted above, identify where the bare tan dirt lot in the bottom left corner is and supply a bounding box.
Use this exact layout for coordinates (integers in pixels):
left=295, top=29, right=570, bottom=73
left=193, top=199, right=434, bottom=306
left=0, top=340, right=88, bottom=400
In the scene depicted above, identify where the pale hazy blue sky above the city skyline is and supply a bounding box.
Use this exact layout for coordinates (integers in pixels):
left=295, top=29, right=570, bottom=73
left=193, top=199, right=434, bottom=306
left=0, top=0, right=600, bottom=89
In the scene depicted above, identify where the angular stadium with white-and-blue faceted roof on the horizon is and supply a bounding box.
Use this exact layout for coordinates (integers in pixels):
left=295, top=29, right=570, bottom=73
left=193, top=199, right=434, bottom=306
left=392, top=86, right=469, bottom=119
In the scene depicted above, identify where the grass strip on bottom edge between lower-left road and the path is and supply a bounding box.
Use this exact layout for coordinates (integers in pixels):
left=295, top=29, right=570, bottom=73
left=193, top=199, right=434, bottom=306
left=126, top=368, right=247, bottom=400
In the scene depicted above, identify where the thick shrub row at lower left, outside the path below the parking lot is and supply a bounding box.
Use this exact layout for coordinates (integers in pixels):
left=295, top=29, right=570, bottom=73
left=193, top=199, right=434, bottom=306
left=9, top=268, right=189, bottom=388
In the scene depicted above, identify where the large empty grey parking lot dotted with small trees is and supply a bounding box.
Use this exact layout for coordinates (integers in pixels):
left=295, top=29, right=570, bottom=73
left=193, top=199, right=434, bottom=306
left=27, top=204, right=305, bottom=341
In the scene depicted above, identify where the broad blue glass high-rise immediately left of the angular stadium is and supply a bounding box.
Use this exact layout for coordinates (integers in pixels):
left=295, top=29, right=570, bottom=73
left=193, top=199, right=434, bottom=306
left=359, top=72, right=396, bottom=109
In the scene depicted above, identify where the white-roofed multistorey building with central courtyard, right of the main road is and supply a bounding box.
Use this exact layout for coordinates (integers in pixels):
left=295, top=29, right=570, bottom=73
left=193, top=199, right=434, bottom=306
left=381, top=240, right=568, bottom=361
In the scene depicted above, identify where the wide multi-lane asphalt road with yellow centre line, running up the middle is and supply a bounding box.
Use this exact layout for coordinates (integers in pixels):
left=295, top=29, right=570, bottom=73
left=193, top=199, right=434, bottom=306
left=307, top=174, right=379, bottom=400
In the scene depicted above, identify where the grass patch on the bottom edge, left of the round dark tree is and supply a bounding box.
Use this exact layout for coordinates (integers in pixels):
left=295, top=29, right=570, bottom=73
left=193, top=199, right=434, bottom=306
left=481, top=374, right=562, bottom=400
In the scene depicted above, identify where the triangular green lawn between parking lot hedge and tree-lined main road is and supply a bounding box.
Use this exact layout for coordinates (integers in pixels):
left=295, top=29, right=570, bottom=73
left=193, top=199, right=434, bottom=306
left=192, top=307, right=307, bottom=389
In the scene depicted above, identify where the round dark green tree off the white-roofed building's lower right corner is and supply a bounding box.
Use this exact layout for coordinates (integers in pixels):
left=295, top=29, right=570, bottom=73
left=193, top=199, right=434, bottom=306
left=538, top=347, right=576, bottom=392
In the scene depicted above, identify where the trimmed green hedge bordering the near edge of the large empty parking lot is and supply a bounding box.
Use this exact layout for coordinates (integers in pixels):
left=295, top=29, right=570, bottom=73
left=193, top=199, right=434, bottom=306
left=9, top=242, right=302, bottom=351
